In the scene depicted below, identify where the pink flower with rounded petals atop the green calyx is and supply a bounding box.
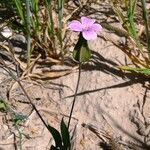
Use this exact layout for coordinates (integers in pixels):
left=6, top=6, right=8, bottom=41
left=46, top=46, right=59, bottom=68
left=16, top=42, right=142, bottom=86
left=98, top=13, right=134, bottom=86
left=69, top=17, right=102, bottom=40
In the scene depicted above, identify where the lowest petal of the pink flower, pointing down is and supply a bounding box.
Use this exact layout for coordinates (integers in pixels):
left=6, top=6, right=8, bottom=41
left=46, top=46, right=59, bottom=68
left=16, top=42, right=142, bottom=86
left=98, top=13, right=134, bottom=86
left=82, top=30, right=97, bottom=40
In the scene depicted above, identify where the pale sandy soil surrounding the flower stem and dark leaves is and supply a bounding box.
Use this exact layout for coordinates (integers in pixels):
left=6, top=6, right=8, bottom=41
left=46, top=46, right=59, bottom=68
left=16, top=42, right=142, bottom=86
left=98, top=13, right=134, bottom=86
left=0, top=0, right=150, bottom=150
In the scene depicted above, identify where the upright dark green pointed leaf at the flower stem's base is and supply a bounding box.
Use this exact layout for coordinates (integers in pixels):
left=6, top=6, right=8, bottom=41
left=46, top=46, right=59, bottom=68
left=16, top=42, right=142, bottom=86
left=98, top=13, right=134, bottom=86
left=61, top=118, right=70, bottom=150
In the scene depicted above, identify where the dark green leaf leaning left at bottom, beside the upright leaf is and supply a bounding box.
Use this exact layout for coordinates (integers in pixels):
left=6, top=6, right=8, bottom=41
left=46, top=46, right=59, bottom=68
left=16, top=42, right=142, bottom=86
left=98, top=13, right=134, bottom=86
left=48, top=125, right=62, bottom=148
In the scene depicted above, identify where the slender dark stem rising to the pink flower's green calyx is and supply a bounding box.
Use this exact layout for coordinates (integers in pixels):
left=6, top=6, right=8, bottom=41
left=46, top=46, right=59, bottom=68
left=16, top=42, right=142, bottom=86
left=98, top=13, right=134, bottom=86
left=68, top=63, right=82, bottom=129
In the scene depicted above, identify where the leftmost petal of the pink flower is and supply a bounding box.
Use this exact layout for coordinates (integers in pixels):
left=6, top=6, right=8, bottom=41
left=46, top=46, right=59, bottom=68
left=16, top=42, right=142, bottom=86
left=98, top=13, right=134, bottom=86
left=68, top=20, right=82, bottom=31
